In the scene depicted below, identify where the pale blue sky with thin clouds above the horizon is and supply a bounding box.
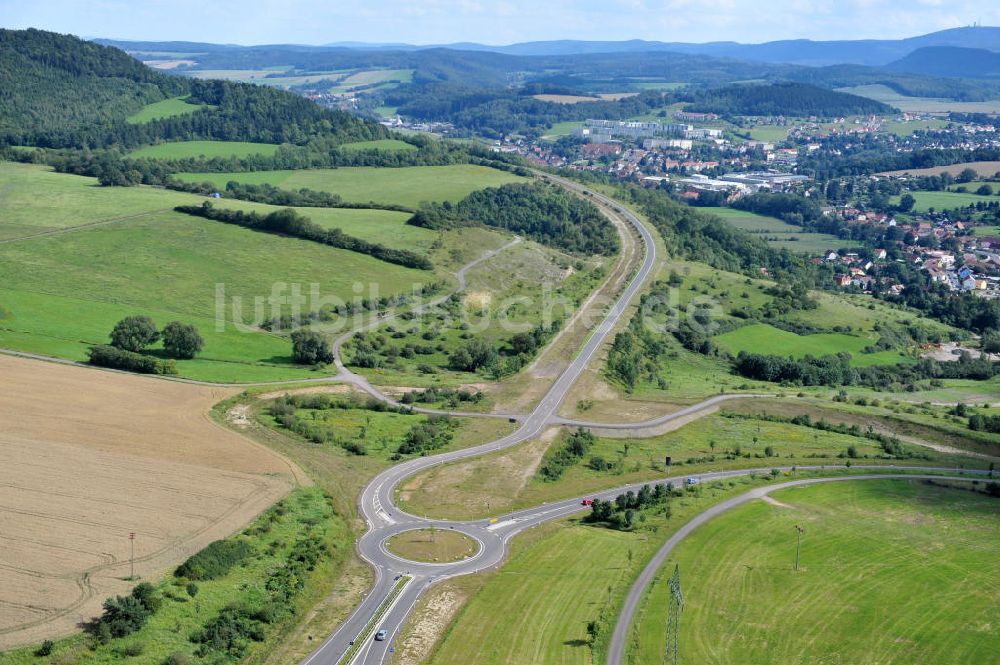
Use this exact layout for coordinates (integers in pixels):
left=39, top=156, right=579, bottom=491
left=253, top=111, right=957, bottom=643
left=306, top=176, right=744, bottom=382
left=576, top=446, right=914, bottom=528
left=0, top=0, right=1000, bottom=44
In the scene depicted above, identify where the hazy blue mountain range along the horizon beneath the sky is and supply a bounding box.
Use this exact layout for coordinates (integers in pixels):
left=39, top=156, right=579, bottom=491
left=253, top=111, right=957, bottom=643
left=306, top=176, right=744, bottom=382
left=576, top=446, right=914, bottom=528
left=95, top=26, right=1000, bottom=71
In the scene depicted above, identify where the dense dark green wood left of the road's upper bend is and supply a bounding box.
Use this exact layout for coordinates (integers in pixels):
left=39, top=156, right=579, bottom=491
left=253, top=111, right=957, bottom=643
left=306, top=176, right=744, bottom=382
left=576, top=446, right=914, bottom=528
left=409, top=183, right=618, bottom=256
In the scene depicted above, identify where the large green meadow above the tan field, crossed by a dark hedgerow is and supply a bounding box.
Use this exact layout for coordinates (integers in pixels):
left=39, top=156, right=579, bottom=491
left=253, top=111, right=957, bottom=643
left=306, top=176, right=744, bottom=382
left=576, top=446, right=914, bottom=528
left=0, top=163, right=437, bottom=382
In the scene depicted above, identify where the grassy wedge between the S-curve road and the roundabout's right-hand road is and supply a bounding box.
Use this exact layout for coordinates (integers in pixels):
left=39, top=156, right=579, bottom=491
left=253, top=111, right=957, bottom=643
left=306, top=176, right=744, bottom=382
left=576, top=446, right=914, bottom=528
left=399, top=408, right=995, bottom=519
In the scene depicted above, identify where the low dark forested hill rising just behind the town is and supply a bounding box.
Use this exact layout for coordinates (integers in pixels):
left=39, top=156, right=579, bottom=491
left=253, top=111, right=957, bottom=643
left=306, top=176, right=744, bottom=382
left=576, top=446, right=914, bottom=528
left=682, top=83, right=893, bottom=117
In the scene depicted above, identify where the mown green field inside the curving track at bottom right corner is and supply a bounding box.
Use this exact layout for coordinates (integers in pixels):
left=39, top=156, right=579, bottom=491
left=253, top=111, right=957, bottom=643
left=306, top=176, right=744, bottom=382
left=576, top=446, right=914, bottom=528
left=627, top=480, right=1000, bottom=664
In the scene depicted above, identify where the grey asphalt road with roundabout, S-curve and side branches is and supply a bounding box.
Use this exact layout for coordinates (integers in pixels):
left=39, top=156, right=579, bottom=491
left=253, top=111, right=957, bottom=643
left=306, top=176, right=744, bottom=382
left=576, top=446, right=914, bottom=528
left=303, top=176, right=996, bottom=665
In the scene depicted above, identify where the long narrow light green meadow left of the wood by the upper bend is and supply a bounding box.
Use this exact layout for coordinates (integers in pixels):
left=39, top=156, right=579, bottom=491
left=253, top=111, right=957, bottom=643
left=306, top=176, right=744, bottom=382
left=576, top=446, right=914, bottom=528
left=177, top=164, right=524, bottom=207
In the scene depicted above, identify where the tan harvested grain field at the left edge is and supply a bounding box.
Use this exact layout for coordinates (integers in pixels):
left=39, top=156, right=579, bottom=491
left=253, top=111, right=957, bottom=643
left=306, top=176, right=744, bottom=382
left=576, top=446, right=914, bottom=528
left=0, top=355, right=302, bottom=650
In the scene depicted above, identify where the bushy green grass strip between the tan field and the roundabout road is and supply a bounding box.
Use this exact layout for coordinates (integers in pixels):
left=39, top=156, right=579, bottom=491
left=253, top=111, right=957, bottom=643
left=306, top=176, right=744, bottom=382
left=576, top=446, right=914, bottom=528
left=0, top=488, right=351, bottom=665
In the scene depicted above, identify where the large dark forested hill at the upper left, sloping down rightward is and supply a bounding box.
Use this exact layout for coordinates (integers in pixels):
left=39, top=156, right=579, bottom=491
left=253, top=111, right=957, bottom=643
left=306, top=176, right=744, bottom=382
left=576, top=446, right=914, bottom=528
left=0, top=30, right=387, bottom=148
